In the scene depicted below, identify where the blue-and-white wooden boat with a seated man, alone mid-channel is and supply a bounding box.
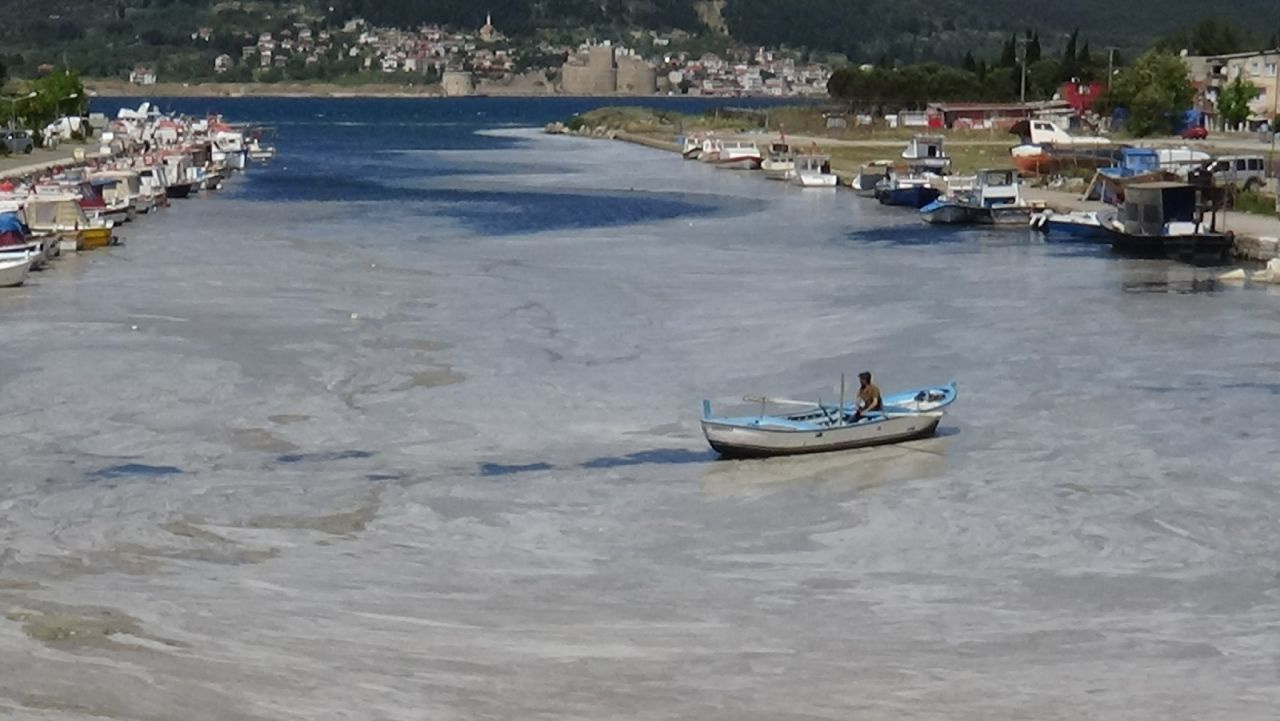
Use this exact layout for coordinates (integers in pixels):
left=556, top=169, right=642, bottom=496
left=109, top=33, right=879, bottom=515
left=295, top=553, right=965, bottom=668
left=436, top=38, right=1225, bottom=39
left=701, top=382, right=956, bottom=458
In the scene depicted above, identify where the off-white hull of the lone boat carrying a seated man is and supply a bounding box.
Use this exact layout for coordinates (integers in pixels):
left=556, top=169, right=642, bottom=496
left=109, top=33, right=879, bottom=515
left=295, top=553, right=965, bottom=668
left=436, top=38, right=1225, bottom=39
left=703, top=412, right=942, bottom=458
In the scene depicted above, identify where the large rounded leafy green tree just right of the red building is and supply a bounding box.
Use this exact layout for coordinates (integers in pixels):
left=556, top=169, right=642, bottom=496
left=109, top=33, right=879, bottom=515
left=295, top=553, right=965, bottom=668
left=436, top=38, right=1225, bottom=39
left=1107, top=50, right=1196, bottom=137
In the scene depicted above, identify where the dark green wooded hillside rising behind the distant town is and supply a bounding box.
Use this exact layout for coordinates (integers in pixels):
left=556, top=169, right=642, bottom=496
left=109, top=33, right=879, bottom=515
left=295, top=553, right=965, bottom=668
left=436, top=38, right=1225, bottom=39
left=0, top=0, right=1280, bottom=76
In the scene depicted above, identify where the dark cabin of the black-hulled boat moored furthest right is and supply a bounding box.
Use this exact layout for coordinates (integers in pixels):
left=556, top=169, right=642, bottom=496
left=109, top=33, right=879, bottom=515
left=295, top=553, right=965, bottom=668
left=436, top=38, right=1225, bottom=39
left=1121, top=182, right=1221, bottom=236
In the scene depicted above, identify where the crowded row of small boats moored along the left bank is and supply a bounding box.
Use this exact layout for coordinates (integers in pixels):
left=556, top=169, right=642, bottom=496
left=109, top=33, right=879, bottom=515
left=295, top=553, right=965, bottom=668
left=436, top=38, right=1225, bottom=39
left=0, top=104, right=275, bottom=288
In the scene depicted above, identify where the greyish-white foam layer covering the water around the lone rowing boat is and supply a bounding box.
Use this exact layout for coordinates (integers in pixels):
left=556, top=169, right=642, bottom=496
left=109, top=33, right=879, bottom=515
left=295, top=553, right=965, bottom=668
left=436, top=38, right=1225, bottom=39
left=0, top=102, right=1280, bottom=721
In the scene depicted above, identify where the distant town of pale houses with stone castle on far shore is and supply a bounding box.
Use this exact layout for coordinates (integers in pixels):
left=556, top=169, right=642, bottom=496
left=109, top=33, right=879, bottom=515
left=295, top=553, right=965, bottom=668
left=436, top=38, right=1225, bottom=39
left=129, top=17, right=832, bottom=97
